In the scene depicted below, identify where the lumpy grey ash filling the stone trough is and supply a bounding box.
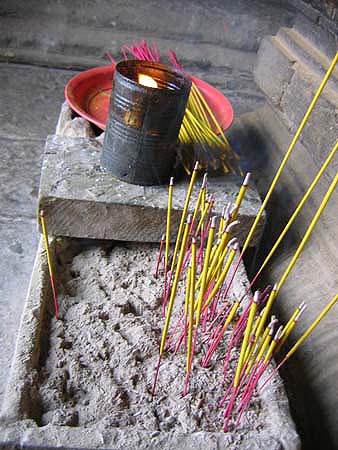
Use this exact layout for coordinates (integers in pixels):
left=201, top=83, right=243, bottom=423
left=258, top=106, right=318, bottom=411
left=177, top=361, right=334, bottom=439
left=39, top=243, right=263, bottom=433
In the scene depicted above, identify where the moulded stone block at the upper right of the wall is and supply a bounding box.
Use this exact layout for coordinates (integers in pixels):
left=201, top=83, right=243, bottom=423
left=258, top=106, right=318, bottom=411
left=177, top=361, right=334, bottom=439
left=255, top=14, right=338, bottom=169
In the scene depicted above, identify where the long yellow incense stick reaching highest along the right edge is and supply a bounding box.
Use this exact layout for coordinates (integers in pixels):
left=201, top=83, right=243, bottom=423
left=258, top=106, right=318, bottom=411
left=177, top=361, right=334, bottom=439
left=242, top=52, right=338, bottom=252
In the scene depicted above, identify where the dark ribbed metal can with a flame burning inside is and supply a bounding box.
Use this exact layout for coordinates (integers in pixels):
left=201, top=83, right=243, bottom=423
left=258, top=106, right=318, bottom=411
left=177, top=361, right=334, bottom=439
left=101, top=60, right=191, bottom=185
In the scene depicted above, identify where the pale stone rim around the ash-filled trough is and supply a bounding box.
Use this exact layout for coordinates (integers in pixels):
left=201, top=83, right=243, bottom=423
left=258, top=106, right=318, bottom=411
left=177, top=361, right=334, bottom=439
left=0, top=239, right=300, bottom=450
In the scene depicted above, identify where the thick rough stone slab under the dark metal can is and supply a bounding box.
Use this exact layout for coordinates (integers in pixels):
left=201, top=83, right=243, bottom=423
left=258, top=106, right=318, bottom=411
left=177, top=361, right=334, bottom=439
left=39, top=135, right=264, bottom=246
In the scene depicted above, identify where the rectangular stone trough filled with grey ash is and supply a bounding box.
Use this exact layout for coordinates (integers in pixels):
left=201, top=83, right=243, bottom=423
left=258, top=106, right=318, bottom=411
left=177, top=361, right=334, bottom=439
left=1, top=239, right=299, bottom=450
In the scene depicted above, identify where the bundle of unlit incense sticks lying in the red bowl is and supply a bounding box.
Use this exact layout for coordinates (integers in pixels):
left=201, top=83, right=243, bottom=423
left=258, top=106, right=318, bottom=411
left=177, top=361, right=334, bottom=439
left=107, top=39, right=241, bottom=175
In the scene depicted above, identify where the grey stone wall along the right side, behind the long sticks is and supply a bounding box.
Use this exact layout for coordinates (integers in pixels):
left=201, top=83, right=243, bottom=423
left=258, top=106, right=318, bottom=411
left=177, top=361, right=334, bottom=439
left=254, top=12, right=338, bottom=449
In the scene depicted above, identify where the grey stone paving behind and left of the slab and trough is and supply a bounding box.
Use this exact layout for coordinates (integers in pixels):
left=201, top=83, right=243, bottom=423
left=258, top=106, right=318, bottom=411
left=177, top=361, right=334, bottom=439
left=0, top=0, right=333, bottom=449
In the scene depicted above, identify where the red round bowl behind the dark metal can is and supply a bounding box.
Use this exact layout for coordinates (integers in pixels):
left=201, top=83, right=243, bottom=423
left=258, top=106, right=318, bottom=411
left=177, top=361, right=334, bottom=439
left=65, top=66, right=234, bottom=130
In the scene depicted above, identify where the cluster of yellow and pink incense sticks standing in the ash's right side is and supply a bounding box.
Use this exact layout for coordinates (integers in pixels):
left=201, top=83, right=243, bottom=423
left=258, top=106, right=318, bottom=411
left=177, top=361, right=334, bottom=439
left=153, top=53, right=338, bottom=431
